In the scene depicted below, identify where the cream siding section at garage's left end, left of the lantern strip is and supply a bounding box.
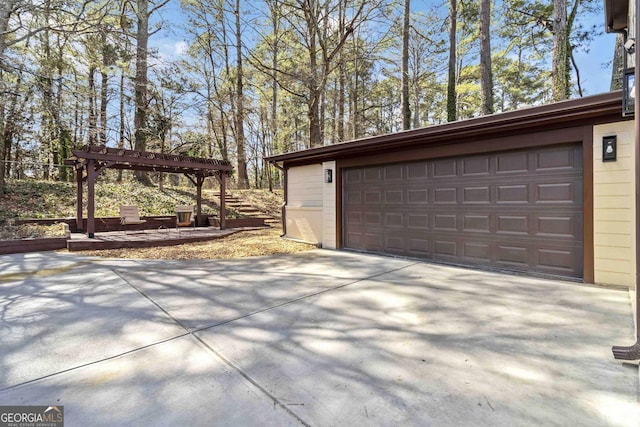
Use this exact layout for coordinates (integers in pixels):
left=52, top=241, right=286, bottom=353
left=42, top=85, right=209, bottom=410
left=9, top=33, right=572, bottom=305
left=285, top=164, right=323, bottom=243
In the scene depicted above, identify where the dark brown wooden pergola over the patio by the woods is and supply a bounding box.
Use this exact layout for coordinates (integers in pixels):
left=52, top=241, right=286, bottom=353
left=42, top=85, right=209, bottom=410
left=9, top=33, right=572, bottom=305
left=65, top=145, right=233, bottom=238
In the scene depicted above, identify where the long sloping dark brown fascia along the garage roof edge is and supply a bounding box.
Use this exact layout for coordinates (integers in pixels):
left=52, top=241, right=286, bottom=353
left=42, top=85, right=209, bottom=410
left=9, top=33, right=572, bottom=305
left=265, top=91, right=625, bottom=167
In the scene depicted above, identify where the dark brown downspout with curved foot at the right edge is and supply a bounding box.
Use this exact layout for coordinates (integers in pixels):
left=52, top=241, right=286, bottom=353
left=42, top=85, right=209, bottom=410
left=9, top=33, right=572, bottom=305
left=612, top=0, right=640, bottom=360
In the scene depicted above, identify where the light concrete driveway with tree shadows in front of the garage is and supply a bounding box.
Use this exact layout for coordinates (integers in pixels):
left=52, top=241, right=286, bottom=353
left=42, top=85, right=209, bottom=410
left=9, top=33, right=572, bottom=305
left=0, top=250, right=640, bottom=426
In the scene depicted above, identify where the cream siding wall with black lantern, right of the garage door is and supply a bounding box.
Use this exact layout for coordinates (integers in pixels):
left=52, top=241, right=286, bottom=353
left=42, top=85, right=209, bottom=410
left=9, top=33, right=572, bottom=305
left=593, top=121, right=635, bottom=288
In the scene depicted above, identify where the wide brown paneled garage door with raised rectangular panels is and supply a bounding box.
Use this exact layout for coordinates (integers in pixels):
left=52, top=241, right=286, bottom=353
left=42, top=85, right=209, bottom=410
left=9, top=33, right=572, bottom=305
left=343, top=145, right=583, bottom=277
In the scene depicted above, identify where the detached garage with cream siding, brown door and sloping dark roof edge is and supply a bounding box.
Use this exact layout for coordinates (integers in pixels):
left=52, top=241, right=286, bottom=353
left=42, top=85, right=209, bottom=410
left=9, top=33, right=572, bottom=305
left=268, top=92, right=640, bottom=288
